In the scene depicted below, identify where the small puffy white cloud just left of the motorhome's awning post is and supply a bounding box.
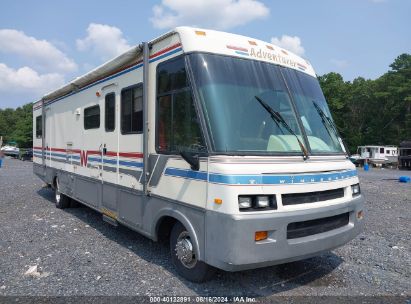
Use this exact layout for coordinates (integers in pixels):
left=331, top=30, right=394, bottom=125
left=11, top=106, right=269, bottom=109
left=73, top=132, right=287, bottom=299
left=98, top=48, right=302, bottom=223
left=76, top=23, right=131, bottom=60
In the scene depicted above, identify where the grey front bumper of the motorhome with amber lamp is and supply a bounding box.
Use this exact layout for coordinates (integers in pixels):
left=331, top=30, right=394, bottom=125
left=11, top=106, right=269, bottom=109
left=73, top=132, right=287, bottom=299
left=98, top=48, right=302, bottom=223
left=205, top=195, right=364, bottom=271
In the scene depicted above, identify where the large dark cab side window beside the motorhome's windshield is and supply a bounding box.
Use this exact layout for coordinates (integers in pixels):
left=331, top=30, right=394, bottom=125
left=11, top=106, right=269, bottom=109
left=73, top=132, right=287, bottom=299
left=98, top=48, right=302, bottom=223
left=156, top=57, right=205, bottom=154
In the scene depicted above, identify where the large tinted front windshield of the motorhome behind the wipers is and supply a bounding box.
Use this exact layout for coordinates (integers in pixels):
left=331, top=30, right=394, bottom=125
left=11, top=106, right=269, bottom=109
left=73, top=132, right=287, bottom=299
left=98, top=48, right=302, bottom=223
left=188, top=53, right=343, bottom=154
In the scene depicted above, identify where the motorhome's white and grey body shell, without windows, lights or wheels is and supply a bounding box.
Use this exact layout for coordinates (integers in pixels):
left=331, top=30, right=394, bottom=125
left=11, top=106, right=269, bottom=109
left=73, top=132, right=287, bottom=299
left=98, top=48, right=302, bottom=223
left=33, top=27, right=363, bottom=271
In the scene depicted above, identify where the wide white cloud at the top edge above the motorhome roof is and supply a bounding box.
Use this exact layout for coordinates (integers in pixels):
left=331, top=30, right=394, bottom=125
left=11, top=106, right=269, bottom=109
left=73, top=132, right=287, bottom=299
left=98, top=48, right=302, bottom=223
left=150, top=0, right=270, bottom=29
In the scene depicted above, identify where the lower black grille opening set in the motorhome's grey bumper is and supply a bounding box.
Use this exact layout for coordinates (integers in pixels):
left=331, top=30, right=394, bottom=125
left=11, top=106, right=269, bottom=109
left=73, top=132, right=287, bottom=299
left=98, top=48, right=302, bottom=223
left=287, top=212, right=350, bottom=239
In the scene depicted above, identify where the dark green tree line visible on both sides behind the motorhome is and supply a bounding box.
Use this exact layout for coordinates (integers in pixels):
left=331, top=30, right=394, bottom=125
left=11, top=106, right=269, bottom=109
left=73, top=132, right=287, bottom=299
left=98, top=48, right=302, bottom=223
left=0, top=54, right=411, bottom=152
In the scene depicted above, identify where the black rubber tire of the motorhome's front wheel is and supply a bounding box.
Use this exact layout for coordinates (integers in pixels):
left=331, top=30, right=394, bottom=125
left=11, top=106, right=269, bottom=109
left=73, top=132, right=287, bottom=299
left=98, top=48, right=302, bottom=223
left=170, top=222, right=215, bottom=283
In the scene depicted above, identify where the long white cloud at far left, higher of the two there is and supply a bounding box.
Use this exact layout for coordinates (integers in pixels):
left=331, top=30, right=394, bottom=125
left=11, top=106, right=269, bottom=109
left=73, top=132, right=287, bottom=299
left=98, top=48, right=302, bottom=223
left=0, top=29, right=77, bottom=72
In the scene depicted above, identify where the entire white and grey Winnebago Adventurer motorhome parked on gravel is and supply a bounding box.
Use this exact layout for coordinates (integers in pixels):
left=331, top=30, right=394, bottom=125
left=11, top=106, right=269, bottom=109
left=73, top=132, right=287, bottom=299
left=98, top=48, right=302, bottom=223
left=33, top=27, right=363, bottom=281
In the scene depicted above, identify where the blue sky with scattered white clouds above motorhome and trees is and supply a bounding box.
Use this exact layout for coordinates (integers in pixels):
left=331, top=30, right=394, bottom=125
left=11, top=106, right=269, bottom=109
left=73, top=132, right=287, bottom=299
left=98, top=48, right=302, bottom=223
left=0, top=0, right=411, bottom=108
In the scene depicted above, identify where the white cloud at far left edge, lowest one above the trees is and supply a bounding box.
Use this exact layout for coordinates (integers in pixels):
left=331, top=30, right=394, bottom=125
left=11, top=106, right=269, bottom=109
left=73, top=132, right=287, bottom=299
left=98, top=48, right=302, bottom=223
left=0, top=63, right=64, bottom=98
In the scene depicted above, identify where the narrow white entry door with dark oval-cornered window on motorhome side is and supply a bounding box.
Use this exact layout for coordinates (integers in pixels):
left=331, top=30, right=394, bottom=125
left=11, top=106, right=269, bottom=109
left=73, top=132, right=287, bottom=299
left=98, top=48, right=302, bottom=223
left=101, top=90, right=120, bottom=212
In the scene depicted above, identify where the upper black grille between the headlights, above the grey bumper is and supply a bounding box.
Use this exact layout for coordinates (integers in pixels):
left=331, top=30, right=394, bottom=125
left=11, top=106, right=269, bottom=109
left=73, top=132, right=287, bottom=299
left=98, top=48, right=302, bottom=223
left=281, top=188, right=344, bottom=206
